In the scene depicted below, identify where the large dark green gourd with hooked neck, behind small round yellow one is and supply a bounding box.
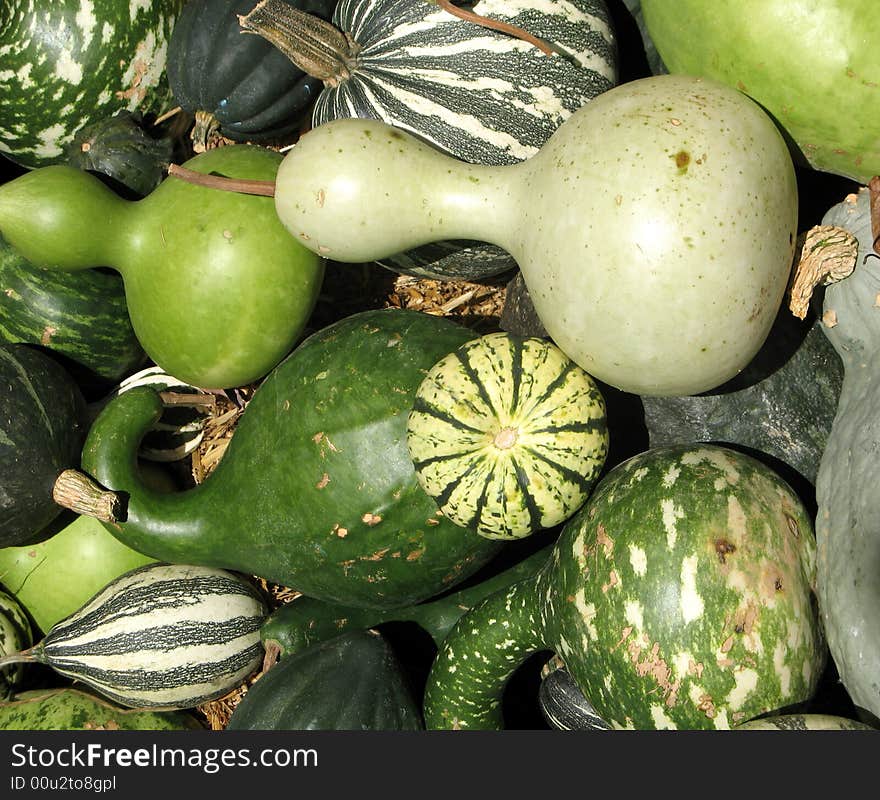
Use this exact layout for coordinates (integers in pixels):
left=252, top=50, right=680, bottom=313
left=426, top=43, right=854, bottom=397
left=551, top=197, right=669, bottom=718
left=75, top=309, right=500, bottom=608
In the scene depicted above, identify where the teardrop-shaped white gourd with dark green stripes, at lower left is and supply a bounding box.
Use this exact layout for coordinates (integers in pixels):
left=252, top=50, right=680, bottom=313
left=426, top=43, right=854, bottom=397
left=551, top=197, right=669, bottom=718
left=0, top=563, right=268, bottom=709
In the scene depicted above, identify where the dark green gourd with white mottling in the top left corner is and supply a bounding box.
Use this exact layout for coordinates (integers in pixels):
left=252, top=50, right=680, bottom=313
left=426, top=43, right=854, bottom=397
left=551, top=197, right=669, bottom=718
left=0, top=0, right=183, bottom=167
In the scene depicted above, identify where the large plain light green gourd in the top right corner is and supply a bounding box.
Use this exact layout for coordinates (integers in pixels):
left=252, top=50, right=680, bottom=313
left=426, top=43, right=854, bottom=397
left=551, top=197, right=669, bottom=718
left=641, top=0, right=880, bottom=183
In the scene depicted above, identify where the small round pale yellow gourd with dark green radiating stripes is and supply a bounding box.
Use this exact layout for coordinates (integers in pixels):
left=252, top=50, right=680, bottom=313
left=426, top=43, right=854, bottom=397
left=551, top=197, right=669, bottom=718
left=407, top=332, right=608, bottom=539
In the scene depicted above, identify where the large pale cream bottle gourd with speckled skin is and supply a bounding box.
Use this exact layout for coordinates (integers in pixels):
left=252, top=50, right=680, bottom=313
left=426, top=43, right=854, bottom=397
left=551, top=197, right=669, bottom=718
left=275, top=75, right=798, bottom=395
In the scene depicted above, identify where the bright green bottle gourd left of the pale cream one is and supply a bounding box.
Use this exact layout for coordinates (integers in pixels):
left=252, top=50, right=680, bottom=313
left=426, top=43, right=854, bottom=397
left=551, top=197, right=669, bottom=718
left=0, top=145, right=324, bottom=389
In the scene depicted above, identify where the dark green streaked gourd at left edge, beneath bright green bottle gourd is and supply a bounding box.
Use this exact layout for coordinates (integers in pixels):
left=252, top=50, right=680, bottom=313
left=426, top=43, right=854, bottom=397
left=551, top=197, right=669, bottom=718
left=0, top=238, right=146, bottom=389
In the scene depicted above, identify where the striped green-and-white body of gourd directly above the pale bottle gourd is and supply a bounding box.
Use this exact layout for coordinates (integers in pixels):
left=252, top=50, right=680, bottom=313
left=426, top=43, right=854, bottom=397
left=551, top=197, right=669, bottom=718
left=313, top=0, right=616, bottom=164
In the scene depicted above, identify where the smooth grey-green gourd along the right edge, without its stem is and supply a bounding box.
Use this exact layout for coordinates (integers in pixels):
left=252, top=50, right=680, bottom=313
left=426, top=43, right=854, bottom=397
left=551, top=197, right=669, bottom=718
left=816, top=188, right=880, bottom=717
